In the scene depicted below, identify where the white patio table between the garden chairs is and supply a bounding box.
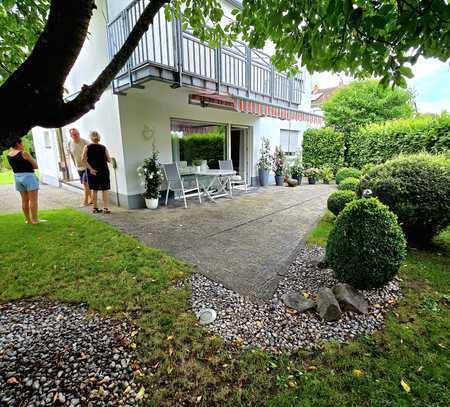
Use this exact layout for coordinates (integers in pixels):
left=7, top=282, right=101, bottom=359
left=180, top=168, right=236, bottom=202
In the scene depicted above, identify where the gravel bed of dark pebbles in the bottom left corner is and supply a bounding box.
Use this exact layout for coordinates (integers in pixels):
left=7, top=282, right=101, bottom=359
left=0, top=300, right=140, bottom=407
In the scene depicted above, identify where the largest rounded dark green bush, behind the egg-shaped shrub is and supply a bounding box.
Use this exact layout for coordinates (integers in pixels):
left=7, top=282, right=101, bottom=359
left=360, top=153, right=450, bottom=246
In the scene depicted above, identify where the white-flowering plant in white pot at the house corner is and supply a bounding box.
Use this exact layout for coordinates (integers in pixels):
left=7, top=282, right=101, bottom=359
left=137, top=150, right=162, bottom=209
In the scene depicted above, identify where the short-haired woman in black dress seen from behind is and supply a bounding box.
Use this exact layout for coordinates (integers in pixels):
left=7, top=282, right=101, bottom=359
left=83, top=131, right=111, bottom=213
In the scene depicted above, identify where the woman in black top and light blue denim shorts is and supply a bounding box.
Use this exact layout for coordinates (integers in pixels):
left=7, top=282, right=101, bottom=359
left=8, top=138, right=39, bottom=225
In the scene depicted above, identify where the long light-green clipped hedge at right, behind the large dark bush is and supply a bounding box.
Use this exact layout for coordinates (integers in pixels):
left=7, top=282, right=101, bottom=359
left=346, top=113, right=450, bottom=168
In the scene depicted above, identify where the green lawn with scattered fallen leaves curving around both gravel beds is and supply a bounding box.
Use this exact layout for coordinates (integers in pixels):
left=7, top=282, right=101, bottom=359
left=0, top=209, right=450, bottom=406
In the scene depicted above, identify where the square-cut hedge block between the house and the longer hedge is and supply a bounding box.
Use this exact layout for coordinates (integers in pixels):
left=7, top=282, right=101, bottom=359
left=303, top=128, right=344, bottom=173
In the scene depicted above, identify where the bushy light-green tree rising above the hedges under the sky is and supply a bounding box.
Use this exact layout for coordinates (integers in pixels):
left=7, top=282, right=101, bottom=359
left=322, top=80, right=414, bottom=134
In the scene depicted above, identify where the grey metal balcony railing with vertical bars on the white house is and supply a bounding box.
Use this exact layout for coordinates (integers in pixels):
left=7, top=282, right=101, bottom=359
left=108, top=0, right=303, bottom=108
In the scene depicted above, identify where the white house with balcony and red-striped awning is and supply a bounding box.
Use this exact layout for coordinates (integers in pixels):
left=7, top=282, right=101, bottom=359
left=33, top=0, right=322, bottom=208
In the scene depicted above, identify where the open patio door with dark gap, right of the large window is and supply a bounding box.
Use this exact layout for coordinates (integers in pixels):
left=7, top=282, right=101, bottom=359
left=227, top=125, right=251, bottom=184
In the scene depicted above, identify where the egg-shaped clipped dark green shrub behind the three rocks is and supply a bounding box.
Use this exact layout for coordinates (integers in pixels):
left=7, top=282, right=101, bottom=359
left=326, top=198, right=406, bottom=289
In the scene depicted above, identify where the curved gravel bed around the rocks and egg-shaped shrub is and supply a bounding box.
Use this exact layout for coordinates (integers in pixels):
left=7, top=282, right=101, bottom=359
left=189, top=247, right=401, bottom=352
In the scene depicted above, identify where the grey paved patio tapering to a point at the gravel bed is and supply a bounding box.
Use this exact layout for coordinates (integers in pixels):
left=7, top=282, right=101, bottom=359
left=102, top=185, right=334, bottom=300
